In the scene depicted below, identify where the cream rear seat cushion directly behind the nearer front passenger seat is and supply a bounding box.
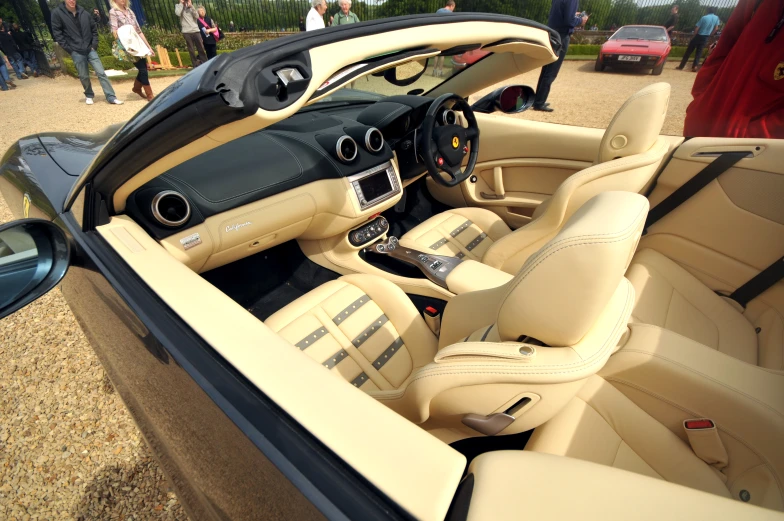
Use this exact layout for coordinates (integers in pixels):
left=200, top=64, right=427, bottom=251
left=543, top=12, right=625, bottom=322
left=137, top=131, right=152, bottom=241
left=525, top=376, right=730, bottom=497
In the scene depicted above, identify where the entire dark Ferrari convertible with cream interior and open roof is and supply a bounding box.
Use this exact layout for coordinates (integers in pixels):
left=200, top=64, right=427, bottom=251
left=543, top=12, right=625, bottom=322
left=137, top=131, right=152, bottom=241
left=0, top=13, right=784, bottom=521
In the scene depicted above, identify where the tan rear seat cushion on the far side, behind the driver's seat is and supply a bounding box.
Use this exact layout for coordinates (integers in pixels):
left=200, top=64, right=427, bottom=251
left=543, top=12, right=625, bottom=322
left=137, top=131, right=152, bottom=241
left=626, top=249, right=758, bottom=365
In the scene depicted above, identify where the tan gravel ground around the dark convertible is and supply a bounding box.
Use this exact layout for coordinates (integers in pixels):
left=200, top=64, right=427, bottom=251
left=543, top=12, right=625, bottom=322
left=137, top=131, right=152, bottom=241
left=0, top=61, right=694, bottom=521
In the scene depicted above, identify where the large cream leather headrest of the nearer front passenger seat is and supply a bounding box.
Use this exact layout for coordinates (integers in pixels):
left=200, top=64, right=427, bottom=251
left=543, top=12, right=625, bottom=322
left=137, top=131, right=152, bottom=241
left=497, top=192, right=648, bottom=346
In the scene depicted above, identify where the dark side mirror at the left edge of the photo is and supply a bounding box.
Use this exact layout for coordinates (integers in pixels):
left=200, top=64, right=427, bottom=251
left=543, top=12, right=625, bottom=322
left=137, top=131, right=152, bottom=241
left=0, top=219, right=70, bottom=318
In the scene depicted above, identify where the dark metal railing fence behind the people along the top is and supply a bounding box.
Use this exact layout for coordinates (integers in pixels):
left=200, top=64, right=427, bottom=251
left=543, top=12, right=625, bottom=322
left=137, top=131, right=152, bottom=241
left=138, top=0, right=738, bottom=31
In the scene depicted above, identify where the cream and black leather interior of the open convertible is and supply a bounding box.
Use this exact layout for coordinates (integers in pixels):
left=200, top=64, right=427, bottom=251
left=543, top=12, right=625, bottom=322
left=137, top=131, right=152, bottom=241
left=86, top=18, right=784, bottom=519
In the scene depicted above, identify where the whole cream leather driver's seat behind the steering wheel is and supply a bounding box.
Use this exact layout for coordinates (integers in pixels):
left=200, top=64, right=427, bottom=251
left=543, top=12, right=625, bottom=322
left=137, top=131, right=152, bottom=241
left=400, top=83, right=670, bottom=274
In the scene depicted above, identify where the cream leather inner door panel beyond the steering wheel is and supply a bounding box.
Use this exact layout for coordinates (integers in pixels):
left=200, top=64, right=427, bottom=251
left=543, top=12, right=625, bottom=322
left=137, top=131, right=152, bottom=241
left=427, top=114, right=604, bottom=228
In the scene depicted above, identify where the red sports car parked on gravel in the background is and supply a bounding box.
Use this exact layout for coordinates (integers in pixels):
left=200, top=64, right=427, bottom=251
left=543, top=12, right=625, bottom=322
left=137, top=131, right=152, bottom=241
left=595, top=25, right=672, bottom=76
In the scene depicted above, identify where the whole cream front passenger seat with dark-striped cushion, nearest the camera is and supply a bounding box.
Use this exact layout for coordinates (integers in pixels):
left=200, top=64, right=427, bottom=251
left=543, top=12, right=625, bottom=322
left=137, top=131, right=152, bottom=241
left=266, top=192, right=648, bottom=437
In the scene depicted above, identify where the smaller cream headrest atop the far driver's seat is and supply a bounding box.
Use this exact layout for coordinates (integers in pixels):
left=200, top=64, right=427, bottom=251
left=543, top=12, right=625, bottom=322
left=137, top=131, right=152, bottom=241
left=597, top=83, right=670, bottom=163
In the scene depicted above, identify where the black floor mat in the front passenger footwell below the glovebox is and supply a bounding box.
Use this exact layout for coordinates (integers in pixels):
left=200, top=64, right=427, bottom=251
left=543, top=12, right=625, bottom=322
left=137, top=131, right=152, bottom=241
left=202, top=241, right=340, bottom=320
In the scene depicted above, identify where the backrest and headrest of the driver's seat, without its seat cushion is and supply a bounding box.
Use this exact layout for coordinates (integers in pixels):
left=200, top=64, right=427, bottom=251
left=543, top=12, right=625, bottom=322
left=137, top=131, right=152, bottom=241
left=482, top=83, right=670, bottom=273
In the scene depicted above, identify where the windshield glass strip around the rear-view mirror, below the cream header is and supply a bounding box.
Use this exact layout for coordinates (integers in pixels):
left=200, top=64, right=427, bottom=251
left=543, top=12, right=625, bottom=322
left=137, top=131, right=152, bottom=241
left=310, top=50, right=490, bottom=103
